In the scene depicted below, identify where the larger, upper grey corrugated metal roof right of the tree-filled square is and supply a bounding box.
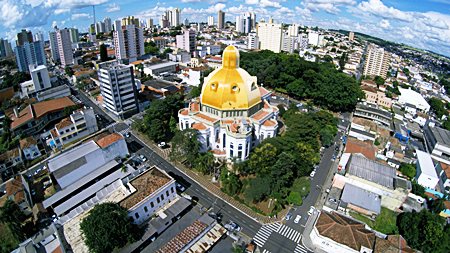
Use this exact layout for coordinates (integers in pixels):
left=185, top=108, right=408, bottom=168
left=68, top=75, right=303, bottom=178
left=348, top=154, right=396, bottom=189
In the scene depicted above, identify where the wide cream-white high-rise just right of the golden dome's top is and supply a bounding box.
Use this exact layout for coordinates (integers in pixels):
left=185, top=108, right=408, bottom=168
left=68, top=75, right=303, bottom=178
left=258, top=23, right=283, bottom=53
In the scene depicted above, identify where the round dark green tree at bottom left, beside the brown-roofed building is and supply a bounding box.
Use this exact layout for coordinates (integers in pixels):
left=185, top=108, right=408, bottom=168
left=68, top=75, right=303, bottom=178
left=80, top=203, right=141, bottom=253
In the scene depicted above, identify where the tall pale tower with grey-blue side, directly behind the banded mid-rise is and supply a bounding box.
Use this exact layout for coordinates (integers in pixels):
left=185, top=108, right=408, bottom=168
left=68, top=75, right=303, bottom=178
left=113, top=20, right=145, bottom=62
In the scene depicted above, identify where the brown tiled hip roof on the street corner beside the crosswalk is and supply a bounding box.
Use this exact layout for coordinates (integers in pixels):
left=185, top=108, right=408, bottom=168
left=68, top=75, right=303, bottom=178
left=315, top=212, right=375, bottom=251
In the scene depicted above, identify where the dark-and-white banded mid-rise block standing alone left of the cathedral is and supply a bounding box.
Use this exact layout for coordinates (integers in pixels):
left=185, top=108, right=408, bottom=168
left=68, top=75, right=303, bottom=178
left=98, top=60, right=139, bottom=119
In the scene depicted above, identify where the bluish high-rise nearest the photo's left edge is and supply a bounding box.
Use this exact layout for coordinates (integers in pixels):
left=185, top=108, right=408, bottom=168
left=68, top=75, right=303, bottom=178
left=14, top=30, right=47, bottom=72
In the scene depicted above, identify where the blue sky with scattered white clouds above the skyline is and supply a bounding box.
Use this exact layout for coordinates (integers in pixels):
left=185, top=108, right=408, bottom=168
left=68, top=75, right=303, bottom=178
left=0, top=0, right=450, bottom=56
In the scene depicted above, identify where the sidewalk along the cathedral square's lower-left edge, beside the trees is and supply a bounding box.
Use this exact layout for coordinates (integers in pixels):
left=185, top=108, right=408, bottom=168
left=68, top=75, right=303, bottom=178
left=132, top=131, right=288, bottom=224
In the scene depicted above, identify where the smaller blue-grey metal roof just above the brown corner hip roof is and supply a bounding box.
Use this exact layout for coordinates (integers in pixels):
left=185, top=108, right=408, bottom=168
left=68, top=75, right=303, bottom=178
left=341, top=183, right=381, bottom=214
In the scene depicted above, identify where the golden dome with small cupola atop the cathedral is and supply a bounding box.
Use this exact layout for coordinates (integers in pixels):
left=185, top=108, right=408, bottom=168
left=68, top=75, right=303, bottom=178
left=200, top=46, right=261, bottom=110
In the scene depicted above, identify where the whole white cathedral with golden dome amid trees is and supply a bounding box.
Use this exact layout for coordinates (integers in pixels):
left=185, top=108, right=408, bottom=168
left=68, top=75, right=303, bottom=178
left=178, top=46, right=278, bottom=160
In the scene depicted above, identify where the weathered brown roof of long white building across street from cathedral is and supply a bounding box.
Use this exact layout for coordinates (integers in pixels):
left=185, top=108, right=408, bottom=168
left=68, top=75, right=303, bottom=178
left=120, top=167, right=173, bottom=209
